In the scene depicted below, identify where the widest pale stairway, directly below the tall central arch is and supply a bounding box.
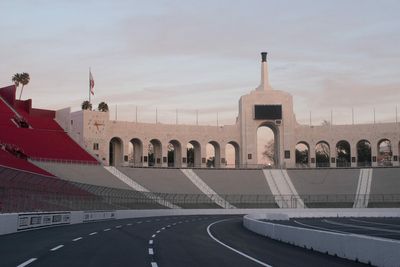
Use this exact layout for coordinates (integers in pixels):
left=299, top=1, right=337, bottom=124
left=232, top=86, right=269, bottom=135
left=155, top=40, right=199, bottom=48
left=263, top=169, right=306, bottom=209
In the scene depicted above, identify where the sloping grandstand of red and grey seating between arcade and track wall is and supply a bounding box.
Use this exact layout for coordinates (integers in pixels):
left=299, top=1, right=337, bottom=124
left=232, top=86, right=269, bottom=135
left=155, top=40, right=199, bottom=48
left=0, top=86, right=400, bottom=212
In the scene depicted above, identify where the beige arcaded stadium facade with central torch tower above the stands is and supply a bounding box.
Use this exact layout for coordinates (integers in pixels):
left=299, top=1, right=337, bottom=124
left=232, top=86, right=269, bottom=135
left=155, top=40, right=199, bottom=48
left=56, top=52, right=400, bottom=168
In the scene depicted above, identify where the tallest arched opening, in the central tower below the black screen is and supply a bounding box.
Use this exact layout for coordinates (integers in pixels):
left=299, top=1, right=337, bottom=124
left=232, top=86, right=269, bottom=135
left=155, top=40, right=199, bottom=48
left=257, top=123, right=279, bottom=167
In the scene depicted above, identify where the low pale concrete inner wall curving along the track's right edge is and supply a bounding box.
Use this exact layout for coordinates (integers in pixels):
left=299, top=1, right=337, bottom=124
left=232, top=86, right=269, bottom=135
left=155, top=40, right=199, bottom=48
left=243, top=214, right=400, bottom=267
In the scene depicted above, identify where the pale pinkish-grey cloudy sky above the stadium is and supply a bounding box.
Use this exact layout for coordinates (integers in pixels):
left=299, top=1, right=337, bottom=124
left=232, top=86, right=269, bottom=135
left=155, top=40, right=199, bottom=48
left=0, top=0, right=400, bottom=125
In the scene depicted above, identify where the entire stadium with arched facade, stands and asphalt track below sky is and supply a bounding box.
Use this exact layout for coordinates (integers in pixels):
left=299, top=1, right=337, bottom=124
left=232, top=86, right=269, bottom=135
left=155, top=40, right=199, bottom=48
left=0, top=52, right=400, bottom=267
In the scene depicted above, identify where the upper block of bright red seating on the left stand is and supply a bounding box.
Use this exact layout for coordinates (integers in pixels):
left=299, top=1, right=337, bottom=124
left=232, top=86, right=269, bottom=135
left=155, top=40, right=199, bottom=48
left=0, top=86, right=98, bottom=164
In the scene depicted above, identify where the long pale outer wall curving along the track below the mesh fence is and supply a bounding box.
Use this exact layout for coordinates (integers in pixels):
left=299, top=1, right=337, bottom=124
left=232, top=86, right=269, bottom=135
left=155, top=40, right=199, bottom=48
left=0, top=209, right=400, bottom=235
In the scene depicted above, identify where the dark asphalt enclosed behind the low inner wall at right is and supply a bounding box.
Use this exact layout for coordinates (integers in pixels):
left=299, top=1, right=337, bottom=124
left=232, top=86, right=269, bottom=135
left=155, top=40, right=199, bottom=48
left=274, top=218, right=400, bottom=240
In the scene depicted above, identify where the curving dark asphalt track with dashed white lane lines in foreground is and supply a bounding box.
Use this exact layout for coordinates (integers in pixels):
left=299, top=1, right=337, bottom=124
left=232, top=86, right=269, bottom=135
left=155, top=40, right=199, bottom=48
left=0, top=215, right=365, bottom=267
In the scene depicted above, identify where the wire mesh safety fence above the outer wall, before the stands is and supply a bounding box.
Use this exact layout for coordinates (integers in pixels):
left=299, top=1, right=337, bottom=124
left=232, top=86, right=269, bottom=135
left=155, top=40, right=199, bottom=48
left=0, top=183, right=400, bottom=213
